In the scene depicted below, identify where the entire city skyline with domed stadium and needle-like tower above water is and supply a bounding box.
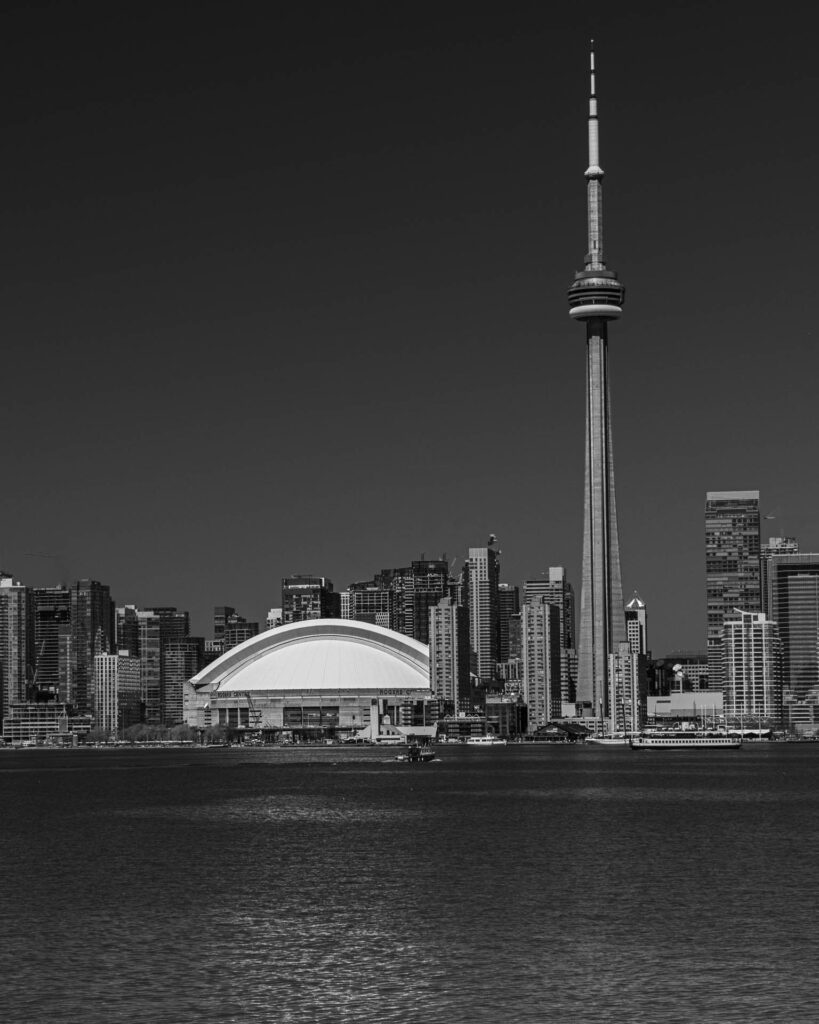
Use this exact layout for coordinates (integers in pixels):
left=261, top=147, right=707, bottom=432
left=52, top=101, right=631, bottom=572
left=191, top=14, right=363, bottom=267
left=0, top=32, right=819, bottom=744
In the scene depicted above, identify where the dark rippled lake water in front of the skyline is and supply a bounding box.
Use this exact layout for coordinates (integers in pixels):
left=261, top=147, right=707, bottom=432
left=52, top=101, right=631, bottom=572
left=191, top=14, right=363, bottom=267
left=0, top=743, right=819, bottom=1024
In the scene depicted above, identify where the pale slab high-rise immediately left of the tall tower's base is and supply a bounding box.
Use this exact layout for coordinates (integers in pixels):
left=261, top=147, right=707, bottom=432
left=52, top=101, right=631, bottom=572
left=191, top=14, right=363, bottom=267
left=520, top=597, right=561, bottom=733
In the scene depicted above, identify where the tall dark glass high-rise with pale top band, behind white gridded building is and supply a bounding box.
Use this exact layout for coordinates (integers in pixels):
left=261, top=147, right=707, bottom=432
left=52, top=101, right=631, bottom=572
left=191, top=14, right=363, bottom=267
left=705, top=490, right=762, bottom=689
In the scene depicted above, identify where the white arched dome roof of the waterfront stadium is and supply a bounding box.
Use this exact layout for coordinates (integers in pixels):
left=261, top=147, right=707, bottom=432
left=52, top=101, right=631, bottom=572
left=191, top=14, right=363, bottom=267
left=191, top=618, right=429, bottom=692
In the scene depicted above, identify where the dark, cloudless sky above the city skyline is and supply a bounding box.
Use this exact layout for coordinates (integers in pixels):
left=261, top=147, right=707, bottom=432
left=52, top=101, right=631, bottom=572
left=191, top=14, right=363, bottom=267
left=0, top=3, right=819, bottom=654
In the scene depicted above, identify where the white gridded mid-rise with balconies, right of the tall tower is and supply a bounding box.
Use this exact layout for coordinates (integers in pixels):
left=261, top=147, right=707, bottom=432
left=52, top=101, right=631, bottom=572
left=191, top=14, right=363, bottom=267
left=723, top=610, right=782, bottom=726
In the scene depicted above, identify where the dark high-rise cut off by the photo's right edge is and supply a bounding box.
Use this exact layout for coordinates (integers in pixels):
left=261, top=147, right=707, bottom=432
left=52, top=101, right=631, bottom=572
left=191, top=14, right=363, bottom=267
left=766, top=552, right=819, bottom=731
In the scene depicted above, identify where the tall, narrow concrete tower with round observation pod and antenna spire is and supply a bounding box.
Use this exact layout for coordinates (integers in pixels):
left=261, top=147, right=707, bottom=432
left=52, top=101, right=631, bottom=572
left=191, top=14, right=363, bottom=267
left=569, top=40, right=626, bottom=715
